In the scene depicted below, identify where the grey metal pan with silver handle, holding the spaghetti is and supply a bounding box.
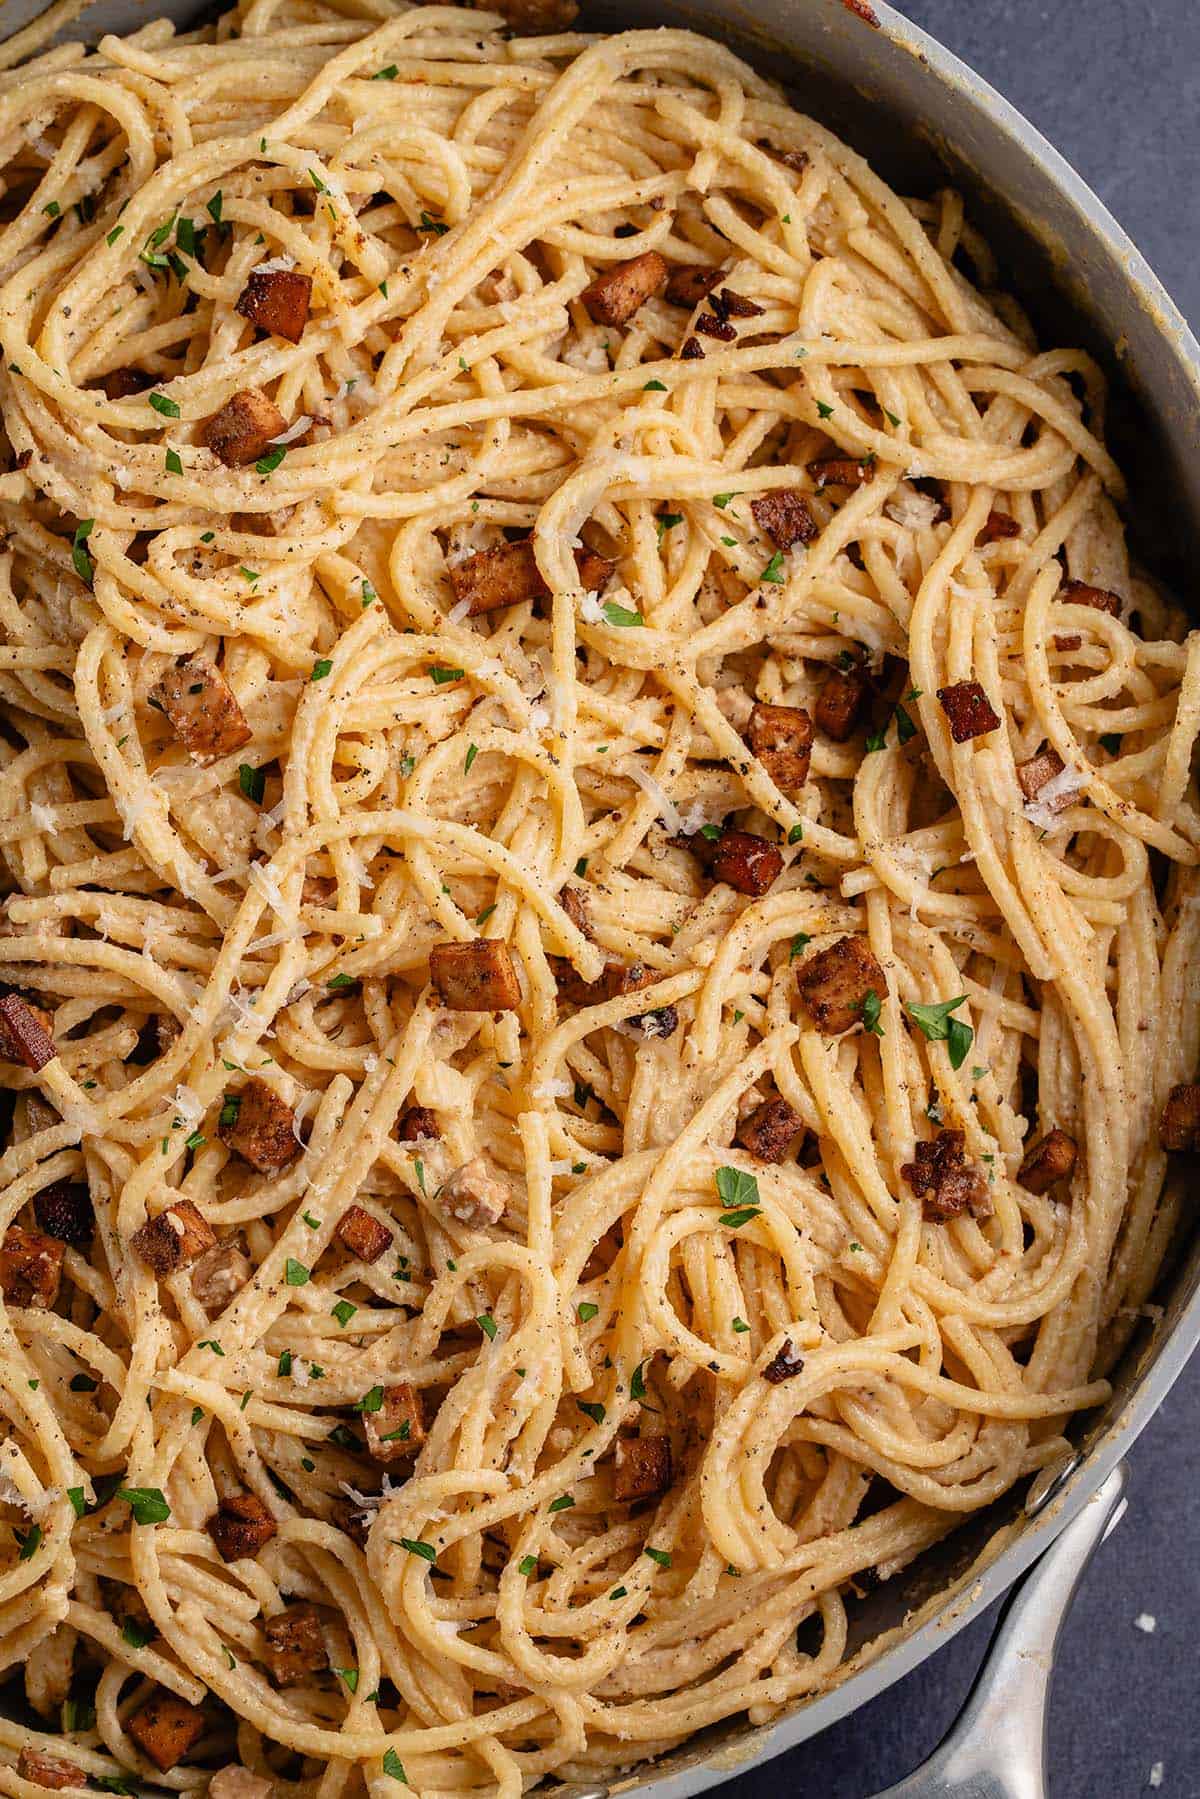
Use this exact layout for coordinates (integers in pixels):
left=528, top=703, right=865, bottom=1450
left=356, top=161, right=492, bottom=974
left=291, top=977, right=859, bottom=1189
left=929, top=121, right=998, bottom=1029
left=0, top=0, right=1200, bottom=1799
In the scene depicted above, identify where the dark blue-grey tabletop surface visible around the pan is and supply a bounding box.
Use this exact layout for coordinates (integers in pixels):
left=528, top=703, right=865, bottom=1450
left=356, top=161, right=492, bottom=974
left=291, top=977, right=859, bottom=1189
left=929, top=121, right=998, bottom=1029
left=734, top=0, right=1200, bottom=1799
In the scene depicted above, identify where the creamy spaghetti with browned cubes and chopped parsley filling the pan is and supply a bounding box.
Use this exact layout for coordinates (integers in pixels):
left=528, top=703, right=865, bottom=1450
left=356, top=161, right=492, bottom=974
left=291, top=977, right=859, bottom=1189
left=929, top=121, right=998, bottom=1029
left=0, top=0, right=1200, bottom=1799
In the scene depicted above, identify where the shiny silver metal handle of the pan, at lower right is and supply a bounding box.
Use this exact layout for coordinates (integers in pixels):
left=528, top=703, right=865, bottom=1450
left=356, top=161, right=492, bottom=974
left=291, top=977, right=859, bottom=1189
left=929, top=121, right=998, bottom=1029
left=878, top=1464, right=1126, bottom=1799
